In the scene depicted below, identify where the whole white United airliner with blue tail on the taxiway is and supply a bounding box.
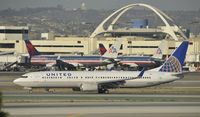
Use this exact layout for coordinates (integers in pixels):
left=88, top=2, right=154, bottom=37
left=13, top=41, right=189, bottom=93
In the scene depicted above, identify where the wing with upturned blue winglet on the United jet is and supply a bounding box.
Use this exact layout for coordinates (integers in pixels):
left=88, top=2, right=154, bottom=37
left=99, top=69, right=145, bottom=88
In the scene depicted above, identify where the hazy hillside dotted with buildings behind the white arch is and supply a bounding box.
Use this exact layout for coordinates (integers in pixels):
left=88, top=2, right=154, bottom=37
left=0, top=7, right=200, bottom=38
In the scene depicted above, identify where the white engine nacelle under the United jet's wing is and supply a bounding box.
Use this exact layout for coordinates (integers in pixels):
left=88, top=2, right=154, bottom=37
left=80, top=83, right=98, bottom=91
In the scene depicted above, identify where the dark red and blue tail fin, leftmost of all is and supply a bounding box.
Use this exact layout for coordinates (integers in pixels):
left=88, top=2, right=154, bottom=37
left=24, top=40, right=40, bottom=57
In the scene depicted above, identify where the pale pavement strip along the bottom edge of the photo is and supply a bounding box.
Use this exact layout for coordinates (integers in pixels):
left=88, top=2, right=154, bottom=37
left=3, top=102, right=200, bottom=117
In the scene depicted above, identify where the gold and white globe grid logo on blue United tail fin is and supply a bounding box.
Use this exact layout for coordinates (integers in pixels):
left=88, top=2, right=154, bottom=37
left=160, top=56, right=182, bottom=72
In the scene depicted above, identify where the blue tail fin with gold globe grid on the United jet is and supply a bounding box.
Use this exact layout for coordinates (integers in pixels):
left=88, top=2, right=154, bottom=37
left=152, top=41, right=189, bottom=72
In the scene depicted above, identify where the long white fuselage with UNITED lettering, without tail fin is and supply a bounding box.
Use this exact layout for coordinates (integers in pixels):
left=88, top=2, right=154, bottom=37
left=14, top=71, right=180, bottom=88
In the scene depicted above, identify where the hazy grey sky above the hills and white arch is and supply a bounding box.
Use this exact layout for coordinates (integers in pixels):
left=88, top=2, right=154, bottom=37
left=0, top=0, right=200, bottom=10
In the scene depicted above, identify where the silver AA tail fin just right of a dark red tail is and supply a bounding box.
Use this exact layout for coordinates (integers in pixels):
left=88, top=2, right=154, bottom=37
left=103, top=38, right=123, bottom=58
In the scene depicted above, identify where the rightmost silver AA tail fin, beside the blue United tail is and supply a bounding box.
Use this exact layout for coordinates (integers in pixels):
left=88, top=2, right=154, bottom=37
left=152, top=40, right=167, bottom=59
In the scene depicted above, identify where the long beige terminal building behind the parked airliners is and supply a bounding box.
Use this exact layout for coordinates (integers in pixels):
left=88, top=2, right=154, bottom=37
left=0, top=28, right=200, bottom=62
